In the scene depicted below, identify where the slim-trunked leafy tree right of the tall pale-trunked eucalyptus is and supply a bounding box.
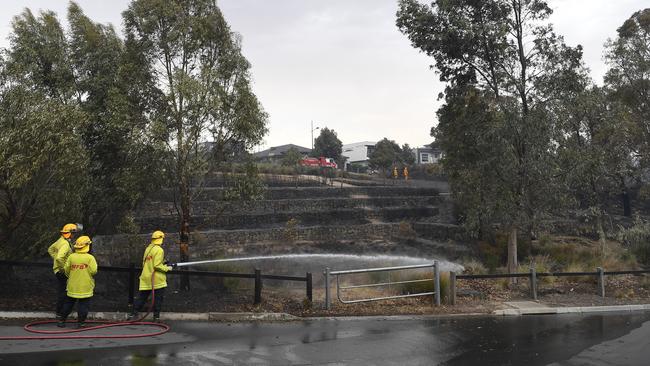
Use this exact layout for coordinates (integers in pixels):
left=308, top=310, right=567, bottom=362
left=553, top=86, right=634, bottom=253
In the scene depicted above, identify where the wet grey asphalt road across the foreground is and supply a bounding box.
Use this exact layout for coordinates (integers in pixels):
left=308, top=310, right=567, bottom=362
left=0, top=313, right=650, bottom=366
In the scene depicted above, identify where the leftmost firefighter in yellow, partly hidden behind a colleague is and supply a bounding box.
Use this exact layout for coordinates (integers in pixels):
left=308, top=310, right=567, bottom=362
left=47, top=224, right=78, bottom=317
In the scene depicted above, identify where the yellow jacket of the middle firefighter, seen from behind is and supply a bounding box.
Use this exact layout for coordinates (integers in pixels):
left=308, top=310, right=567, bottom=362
left=64, top=253, right=97, bottom=299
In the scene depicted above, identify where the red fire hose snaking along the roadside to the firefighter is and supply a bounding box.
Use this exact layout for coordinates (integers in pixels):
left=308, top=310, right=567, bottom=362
left=0, top=271, right=170, bottom=341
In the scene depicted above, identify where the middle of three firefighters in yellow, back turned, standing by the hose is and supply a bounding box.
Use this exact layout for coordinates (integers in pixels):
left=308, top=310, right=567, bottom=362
left=57, top=235, right=97, bottom=328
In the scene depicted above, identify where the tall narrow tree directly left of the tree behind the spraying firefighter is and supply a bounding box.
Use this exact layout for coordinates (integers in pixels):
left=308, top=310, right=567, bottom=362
left=67, top=3, right=163, bottom=231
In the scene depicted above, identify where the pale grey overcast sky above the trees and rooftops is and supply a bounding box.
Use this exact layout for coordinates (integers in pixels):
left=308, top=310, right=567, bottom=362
left=0, top=0, right=650, bottom=149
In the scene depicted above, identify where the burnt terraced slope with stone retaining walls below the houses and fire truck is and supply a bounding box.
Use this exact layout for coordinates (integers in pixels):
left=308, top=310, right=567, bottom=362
left=93, top=176, right=464, bottom=262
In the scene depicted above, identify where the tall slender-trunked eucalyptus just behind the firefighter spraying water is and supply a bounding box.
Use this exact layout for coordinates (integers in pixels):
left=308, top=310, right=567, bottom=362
left=123, top=0, right=267, bottom=288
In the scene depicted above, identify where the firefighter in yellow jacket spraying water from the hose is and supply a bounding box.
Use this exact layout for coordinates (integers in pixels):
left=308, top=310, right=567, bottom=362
left=129, top=231, right=176, bottom=322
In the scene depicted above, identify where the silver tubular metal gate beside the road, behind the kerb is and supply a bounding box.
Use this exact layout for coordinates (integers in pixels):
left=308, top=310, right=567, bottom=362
left=324, top=261, right=440, bottom=310
